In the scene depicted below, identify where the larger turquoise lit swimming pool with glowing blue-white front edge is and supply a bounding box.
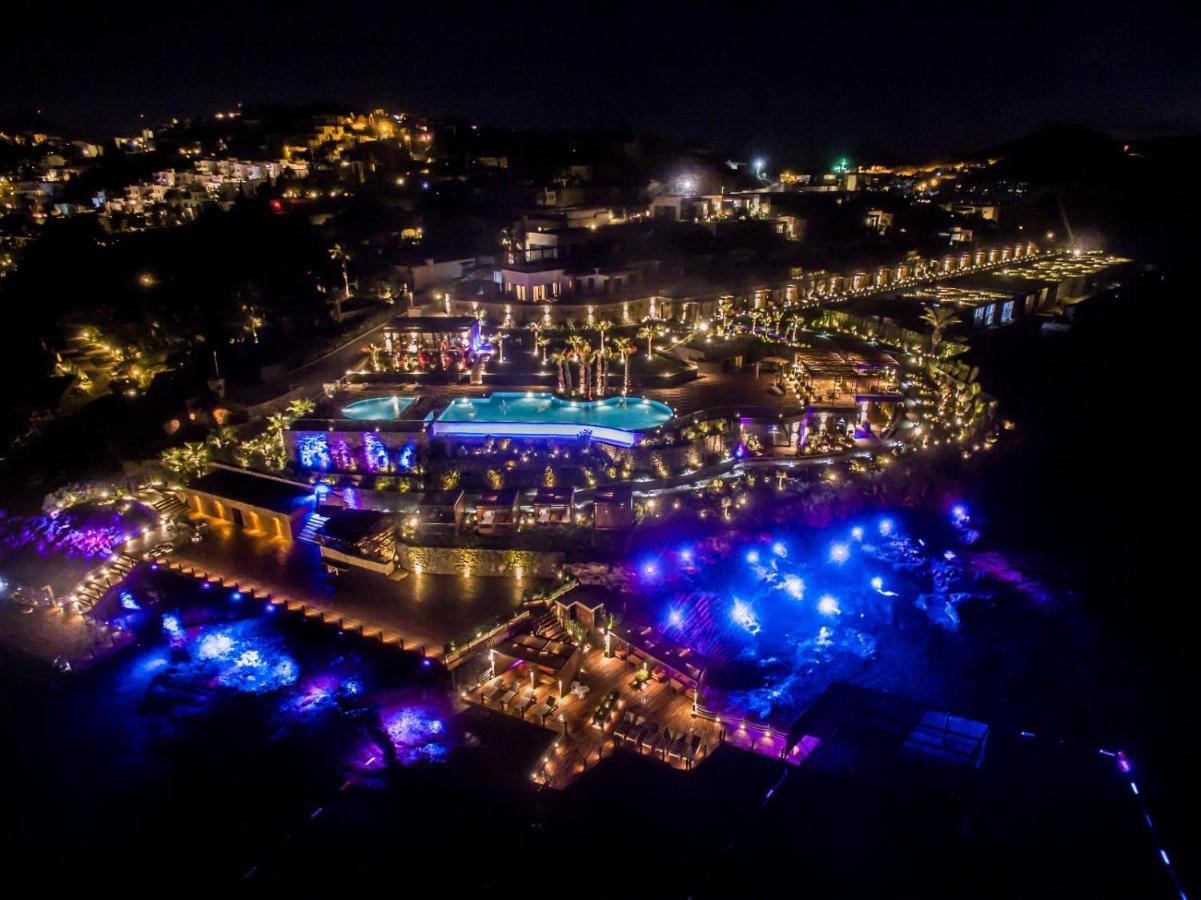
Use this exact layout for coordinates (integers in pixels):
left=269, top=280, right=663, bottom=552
left=434, top=392, right=675, bottom=447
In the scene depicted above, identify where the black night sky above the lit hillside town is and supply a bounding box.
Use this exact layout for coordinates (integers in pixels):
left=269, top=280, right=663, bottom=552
left=9, top=0, right=1201, bottom=162
